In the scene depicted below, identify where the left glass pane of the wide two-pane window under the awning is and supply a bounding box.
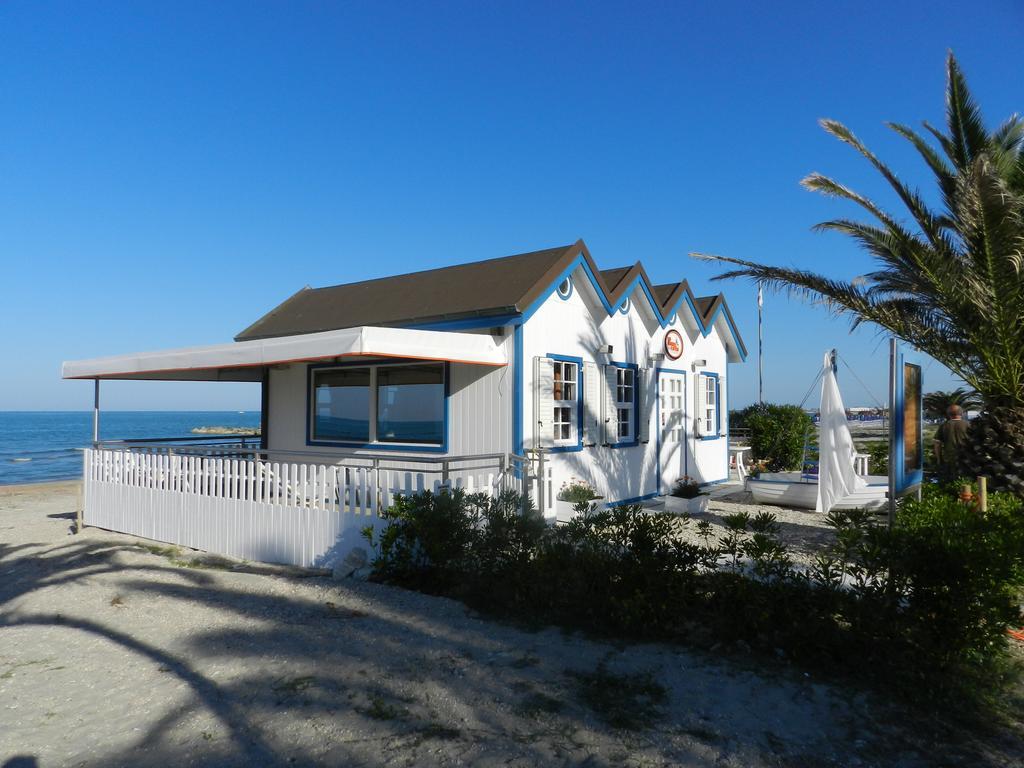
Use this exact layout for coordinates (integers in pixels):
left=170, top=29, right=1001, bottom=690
left=313, top=368, right=370, bottom=442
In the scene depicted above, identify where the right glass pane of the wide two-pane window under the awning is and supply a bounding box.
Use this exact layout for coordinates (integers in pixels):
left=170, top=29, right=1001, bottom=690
left=377, top=365, right=444, bottom=443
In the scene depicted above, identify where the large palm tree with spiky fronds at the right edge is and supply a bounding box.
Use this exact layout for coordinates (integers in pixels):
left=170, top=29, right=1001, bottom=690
left=694, top=53, right=1024, bottom=495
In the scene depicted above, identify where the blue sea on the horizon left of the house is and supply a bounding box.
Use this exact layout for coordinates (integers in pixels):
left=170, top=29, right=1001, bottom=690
left=0, top=411, right=259, bottom=485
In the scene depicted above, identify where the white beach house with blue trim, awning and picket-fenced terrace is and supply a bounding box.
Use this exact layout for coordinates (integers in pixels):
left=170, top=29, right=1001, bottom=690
left=63, top=241, right=745, bottom=565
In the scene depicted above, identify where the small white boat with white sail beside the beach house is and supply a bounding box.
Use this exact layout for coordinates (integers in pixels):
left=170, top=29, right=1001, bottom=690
left=746, top=350, right=889, bottom=512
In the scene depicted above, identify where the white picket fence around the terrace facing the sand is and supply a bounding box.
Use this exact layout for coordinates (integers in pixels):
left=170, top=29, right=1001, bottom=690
left=83, top=449, right=514, bottom=567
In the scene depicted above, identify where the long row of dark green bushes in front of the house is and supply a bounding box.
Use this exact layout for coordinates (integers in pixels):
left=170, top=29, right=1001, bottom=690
left=369, top=487, right=1024, bottom=702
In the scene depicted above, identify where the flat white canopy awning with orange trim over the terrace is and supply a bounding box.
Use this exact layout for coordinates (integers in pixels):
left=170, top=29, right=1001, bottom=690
left=62, top=326, right=508, bottom=381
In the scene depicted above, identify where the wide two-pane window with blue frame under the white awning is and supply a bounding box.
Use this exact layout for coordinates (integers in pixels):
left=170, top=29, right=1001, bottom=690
left=306, top=360, right=450, bottom=453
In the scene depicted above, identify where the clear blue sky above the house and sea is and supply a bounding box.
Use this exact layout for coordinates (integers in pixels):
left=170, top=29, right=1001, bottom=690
left=0, top=0, right=1024, bottom=410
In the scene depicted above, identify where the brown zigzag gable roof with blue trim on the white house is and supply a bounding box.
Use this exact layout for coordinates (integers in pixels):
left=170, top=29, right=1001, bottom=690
left=234, top=240, right=746, bottom=358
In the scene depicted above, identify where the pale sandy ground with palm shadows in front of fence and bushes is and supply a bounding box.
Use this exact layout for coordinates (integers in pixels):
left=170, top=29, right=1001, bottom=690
left=0, top=483, right=1024, bottom=768
